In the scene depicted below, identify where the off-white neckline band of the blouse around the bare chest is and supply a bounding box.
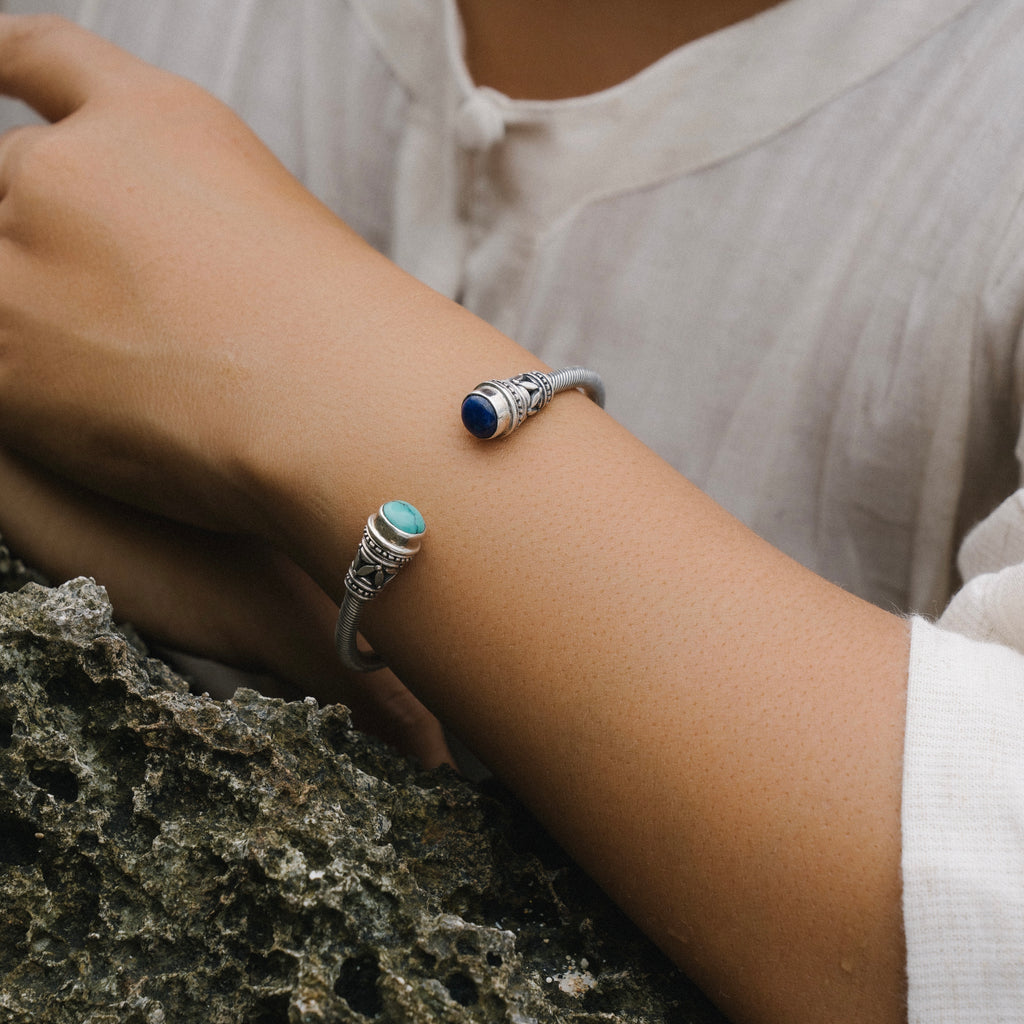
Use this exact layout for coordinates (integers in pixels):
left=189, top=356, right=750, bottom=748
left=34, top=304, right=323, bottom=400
left=350, top=0, right=981, bottom=214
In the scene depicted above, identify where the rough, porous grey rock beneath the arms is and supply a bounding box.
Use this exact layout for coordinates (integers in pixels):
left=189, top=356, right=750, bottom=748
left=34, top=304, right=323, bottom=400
left=0, top=569, right=723, bottom=1024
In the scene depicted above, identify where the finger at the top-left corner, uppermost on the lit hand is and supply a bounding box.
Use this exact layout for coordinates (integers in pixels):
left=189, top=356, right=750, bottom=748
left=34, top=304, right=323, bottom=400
left=0, top=14, right=138, bottom=121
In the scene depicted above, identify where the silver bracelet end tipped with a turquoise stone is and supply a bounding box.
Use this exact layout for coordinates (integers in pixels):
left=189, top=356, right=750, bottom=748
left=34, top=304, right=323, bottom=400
left=334, top=501, right=426, bottom=672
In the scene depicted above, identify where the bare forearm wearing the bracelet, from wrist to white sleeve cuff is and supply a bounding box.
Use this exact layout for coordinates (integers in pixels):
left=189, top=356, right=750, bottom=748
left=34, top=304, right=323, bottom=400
left=241, top=253, right=906, bottom=1021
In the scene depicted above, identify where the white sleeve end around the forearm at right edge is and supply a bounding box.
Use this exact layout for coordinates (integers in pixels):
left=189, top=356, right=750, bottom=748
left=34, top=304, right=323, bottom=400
left=902, top=492, right=1024, bottom=1024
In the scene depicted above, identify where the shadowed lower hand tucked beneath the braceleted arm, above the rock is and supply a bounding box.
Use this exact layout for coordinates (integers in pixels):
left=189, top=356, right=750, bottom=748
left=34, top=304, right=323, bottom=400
left=0, top=449, right=454, bottom=768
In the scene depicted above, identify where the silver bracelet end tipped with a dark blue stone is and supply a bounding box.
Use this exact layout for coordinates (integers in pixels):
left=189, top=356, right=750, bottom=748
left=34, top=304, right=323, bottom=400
left=462, top=367, right=604, bottom=440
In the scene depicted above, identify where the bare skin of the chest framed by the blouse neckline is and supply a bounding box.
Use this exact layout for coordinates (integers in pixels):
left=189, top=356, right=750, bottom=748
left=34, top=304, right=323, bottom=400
left=458, top=0, right=779, bottom=99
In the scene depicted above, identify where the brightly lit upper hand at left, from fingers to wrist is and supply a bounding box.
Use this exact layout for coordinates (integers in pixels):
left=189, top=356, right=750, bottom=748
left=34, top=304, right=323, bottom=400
left=0, top=15, right=378, bottom=529
